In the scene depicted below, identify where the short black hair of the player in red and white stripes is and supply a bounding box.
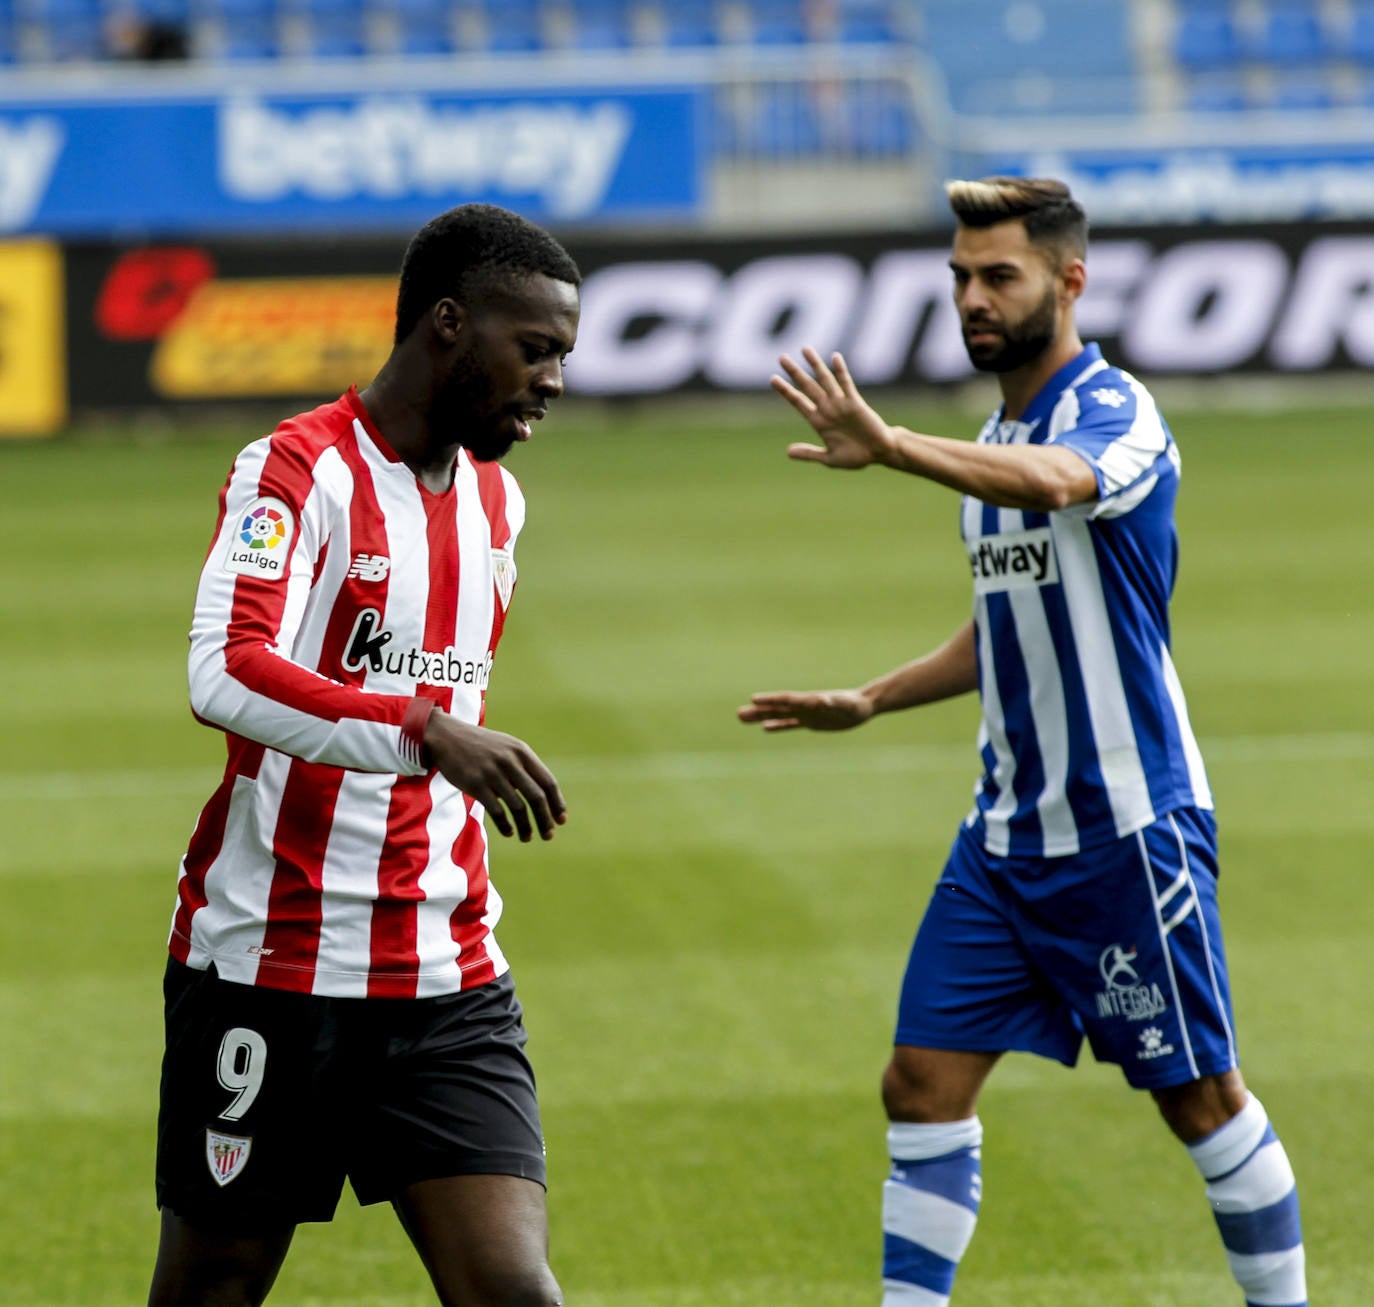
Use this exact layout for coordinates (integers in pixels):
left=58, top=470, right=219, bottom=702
left=396, top=205, right=583, bottom=344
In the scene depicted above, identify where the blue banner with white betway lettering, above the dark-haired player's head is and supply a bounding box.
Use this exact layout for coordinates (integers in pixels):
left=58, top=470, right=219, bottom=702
left=0, top=88, right=702, bottom=238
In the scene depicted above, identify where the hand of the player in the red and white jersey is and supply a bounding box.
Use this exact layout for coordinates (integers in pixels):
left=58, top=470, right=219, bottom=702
left=425, top=708, right=567, bottom=842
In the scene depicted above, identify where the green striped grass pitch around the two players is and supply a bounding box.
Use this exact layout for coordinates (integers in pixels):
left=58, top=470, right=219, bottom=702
left=0, top=397, right=1374, bottom=1307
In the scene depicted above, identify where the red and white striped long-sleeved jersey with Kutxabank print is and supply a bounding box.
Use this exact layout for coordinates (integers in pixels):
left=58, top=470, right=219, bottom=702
left=170, top=390, right=525, bottom=998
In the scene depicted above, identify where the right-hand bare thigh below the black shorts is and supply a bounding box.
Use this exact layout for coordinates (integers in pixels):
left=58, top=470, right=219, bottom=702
left=394, top=1175, right=562, bottom=1307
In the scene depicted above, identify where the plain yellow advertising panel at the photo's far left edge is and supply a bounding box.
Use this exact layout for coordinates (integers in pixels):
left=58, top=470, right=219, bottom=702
left=0, top=241, right=67, bottom=436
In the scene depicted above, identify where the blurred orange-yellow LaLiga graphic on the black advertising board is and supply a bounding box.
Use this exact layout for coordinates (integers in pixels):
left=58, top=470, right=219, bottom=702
left=150, top=276, right=396, bottom=400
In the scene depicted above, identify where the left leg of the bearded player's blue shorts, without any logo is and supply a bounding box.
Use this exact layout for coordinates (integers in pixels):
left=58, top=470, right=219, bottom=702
left=893, top=831, right=1083, bottom=1065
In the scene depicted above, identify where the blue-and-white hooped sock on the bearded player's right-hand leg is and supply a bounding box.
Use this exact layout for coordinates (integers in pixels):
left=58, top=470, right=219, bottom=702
left=1189, top=1094, right=1307, bottom=1307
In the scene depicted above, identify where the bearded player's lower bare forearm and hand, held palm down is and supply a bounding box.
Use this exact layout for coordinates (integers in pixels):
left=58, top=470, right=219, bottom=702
left=739, top=618, right=978, bottom=731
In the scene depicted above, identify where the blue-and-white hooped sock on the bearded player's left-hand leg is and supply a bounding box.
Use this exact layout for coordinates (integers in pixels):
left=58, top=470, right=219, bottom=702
left=882, top=1116, right=982, bottom=1307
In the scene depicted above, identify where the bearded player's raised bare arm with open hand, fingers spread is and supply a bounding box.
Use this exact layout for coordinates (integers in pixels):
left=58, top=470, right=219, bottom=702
left=772, top=349, right=1098, bottom=513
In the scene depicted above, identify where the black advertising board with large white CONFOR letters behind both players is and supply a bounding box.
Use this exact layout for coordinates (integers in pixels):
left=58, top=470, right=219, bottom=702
left=66, top=225, right=1374, bottom=407
